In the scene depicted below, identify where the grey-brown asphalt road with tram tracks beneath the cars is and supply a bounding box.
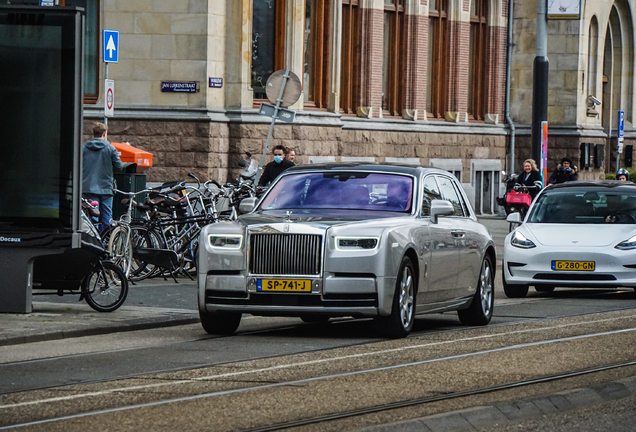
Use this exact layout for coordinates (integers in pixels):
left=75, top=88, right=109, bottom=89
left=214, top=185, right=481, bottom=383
left=0, top=221, right=636, bottom=432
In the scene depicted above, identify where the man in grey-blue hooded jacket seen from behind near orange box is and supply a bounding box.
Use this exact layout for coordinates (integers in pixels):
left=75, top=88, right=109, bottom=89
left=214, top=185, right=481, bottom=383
left=82, top=123, right=124, bottom=232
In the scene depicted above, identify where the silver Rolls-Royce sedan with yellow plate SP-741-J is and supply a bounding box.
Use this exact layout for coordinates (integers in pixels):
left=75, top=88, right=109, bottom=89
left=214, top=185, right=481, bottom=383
left=197, top=164, right=496, bottom=337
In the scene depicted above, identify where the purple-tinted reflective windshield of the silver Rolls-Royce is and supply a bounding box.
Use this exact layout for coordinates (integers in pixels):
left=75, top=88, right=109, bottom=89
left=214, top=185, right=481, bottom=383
left=260, top=171, right=413, bottom=213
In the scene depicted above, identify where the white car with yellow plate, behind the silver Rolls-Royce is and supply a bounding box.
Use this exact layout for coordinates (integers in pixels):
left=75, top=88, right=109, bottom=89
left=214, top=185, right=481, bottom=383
left=502, top=181, right=636, bottom=297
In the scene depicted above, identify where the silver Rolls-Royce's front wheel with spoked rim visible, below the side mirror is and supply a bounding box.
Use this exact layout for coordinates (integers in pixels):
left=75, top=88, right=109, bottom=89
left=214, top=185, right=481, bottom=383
left=375, top=256, right=417, bottom=339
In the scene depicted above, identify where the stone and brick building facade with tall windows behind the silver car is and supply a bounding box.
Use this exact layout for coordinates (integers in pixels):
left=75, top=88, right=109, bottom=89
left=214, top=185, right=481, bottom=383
left=66, top=0, right=508, bottom=212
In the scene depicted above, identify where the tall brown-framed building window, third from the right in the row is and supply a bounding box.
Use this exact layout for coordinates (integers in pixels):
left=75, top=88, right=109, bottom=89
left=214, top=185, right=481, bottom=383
left=382, top=0, right=404, bottom=116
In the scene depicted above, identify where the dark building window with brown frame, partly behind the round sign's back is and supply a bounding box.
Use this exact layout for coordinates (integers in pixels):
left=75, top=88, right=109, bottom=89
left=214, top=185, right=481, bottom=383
left=252, top=0, right=285, bottom=99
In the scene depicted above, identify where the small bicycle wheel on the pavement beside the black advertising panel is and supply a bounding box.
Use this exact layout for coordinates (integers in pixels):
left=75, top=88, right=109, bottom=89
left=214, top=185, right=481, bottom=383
left=82, top=261, right=128, bottom=312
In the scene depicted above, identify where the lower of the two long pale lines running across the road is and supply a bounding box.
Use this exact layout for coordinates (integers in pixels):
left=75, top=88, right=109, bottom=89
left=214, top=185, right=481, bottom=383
left=0, top=328, right=636, bottom=430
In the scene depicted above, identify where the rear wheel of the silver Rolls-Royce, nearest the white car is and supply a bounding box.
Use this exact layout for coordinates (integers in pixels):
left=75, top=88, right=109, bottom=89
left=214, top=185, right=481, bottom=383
left=457, top=255, right=495, bottom=326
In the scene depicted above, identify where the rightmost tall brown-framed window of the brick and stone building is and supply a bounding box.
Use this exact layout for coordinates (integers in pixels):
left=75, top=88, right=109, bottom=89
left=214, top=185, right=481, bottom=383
left=468, top=0, right=488, bottom=120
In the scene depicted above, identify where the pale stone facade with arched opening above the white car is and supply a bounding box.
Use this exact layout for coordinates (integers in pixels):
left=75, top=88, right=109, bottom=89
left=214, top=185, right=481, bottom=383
left=510, top=0, right=636, bottom=179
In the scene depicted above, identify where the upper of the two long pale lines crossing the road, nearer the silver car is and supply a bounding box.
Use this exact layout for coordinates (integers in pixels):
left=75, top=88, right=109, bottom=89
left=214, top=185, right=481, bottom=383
left=0, top=315, right=634, bottom=412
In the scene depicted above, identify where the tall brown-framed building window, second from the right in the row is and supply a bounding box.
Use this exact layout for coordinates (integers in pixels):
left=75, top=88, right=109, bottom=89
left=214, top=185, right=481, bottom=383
left=426, top=0, right=448, bottom=118
